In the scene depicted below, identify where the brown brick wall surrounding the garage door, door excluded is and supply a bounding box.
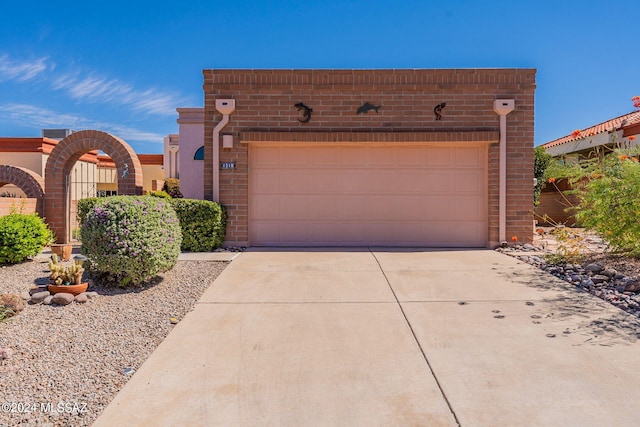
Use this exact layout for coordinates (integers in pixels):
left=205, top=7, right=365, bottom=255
left=203, top=69, right=535, bottom=245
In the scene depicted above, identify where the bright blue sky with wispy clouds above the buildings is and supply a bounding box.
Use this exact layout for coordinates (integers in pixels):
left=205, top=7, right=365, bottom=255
left=0, top=0, right=640, bottom=153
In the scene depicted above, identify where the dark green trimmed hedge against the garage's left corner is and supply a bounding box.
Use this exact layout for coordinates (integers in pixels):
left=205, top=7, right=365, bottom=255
left=171, top=199, right=226, bottom=252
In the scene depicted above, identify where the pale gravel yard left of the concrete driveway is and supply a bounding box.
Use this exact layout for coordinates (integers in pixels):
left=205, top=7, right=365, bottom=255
left=0, top=261, right=227, bottom=426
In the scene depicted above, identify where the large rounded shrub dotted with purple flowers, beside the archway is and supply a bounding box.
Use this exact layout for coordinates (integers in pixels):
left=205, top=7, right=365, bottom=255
left=80, top=196, right=182, bottom=286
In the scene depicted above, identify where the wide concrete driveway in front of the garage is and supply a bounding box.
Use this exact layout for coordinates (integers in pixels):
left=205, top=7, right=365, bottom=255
left=94, top=249, right=640, bottom=426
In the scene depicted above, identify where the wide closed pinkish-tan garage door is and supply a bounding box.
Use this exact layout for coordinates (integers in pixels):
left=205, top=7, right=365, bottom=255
left=249, top=144, right=487, bottom=247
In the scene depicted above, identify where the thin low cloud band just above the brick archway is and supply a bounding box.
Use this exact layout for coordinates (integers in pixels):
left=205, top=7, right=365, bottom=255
left=0, top=104, right=164, bottom=144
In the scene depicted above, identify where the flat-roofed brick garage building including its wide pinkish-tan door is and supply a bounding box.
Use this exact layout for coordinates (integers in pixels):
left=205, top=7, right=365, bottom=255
left=198, top=69, right=535, bottom=247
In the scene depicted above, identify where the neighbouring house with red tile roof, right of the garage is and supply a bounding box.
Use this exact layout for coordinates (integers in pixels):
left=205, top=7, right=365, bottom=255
left=536, top=111, right=640, bottom=225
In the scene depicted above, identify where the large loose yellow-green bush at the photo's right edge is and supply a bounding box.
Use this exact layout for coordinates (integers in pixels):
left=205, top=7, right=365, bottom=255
left=576, top=152, right=640, bottom=257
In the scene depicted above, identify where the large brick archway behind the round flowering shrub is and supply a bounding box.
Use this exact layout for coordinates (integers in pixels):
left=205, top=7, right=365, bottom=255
left=44, top=130, right=142, bottom=243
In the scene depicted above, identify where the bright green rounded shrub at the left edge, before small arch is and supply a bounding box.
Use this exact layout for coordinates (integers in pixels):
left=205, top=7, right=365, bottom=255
left=0, top=214, right=52, bottom=264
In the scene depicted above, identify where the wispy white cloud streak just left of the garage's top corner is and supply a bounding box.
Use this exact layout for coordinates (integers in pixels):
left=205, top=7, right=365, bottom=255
left=53, top=74, right=185, bottom=116
